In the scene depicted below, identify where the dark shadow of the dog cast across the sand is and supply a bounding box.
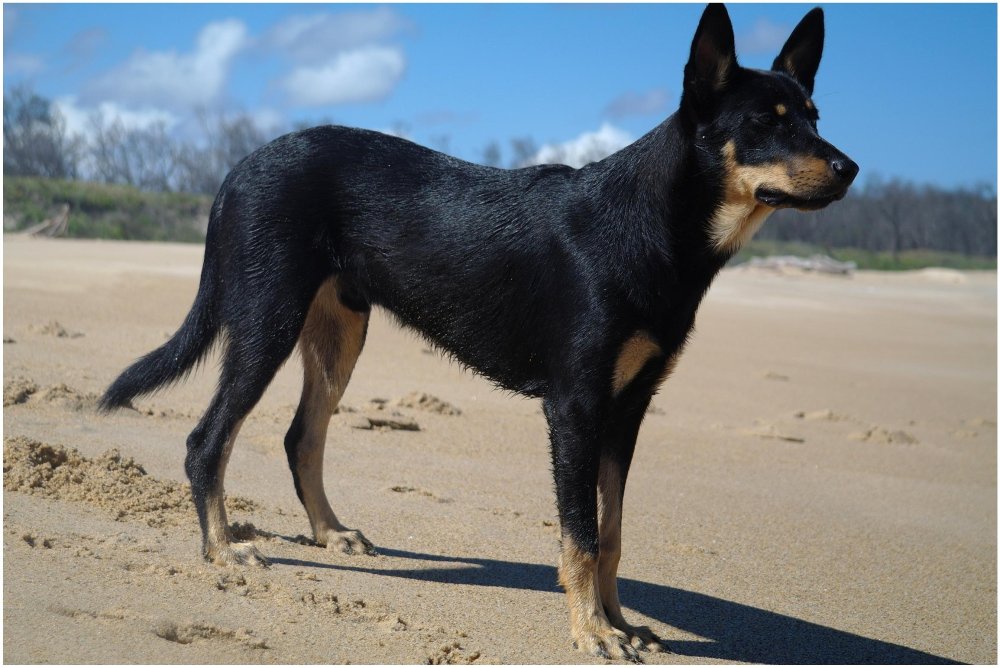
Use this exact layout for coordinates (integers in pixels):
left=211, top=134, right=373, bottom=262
left=272, top=547, right=959, bottom=664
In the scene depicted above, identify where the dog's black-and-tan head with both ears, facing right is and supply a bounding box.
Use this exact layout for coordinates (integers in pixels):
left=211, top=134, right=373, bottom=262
left=681, top=4, right=858, bottom=218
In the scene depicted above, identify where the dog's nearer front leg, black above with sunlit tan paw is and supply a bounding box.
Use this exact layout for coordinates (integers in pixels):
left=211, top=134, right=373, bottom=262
left=544, top=396, right=640, bottom=663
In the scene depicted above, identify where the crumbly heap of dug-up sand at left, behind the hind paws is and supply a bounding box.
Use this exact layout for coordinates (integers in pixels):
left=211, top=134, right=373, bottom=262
left=3, top=436, right=254, bottom=527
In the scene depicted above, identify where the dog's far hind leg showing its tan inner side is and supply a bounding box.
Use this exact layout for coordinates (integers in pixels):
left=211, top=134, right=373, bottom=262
left=285, top=278, right=374, bottom=554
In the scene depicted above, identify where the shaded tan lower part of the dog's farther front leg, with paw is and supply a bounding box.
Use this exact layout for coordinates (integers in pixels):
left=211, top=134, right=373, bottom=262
left=597, top=457, right=668, bottom=652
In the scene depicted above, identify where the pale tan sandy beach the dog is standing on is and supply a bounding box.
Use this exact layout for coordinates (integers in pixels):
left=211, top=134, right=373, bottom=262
left=3, top=236, right=997, bottom=664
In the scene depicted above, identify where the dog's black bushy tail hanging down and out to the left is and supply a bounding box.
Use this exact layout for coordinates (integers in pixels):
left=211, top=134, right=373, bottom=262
left=98, top=214, right=220, bottom=412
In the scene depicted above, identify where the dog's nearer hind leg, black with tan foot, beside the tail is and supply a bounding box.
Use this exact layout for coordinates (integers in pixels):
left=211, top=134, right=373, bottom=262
left=184, top=286, right=308, bottom=565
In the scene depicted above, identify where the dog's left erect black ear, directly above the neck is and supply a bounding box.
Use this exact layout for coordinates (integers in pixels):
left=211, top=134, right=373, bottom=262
left=681, top=3, right=739, bottom=118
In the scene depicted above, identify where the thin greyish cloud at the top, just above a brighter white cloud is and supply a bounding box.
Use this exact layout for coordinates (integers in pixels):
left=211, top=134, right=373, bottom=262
left=263, top=7, right=410, bottom=65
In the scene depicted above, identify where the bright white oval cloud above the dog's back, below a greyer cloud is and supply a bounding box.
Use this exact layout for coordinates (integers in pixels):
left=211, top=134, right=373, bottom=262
left=283, top=46, right=406, bottom=107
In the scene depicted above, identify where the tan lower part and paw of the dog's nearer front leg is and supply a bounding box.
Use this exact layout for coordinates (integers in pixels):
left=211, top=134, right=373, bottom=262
left=559, top=535, right=639, bottom=662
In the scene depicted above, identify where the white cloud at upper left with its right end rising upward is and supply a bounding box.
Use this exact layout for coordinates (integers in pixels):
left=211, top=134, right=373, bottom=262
left=85, top=19, right=248, bottom=110
